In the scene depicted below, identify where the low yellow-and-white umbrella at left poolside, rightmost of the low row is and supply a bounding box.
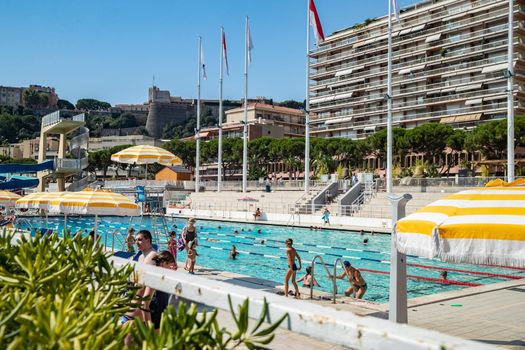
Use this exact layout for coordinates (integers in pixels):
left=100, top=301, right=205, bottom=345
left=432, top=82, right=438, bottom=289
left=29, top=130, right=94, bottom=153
left=50, top=189, right=140, bottom=216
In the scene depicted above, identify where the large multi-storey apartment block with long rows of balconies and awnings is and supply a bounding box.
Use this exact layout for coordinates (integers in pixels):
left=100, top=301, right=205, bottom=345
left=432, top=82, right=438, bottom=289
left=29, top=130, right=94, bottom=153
left=309, top=0, right=525, bottom=139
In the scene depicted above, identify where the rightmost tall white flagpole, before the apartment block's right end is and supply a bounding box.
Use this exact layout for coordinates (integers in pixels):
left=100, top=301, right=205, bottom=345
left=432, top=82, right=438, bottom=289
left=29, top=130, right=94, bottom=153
left=507, top=0, right=514, bottom=182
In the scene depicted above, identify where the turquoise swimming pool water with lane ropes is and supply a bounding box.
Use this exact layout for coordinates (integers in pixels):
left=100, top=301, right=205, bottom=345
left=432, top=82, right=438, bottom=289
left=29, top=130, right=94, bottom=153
left=22, top=217, right=525, bottom=302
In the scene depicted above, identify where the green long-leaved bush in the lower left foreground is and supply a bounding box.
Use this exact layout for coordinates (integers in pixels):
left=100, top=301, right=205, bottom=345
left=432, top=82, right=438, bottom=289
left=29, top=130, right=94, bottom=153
left=0, top=230, right=286, bottom=350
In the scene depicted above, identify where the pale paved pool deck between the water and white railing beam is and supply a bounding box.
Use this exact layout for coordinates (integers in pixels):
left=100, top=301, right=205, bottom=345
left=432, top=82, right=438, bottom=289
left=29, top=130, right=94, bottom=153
left=192, top=268, right=525, bottom=349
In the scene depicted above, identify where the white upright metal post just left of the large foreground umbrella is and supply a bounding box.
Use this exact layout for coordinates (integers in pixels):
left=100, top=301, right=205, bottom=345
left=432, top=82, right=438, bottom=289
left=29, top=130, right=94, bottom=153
left=388, top=193, right=412, bottom=323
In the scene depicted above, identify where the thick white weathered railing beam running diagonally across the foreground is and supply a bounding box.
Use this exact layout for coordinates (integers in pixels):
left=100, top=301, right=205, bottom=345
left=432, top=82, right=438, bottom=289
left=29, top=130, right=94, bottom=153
left=108, top=257, right=495, bottom=350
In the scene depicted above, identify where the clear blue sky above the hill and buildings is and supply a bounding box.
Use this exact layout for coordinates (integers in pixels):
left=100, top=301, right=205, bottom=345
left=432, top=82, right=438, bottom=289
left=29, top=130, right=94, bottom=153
left=0, top=0, right=417, bottom=104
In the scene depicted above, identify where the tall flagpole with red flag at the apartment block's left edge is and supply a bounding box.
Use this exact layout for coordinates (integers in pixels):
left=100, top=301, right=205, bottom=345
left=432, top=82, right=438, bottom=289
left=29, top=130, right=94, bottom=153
left=304, top=0, right=310, bottom=193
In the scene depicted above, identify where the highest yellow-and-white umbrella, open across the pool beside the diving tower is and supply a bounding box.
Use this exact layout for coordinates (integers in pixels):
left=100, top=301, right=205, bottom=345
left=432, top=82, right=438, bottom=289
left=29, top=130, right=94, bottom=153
left=111, top=146, right=182, bottom=165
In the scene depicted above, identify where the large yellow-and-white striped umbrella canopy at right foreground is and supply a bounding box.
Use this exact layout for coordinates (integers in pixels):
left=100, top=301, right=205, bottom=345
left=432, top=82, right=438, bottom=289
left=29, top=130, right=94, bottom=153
left=395, top=180, right=525, bottom=267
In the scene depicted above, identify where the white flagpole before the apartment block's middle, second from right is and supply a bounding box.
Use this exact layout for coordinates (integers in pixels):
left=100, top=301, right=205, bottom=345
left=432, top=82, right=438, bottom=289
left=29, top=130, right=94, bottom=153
left=386, top=0, right=393, bottom=193
